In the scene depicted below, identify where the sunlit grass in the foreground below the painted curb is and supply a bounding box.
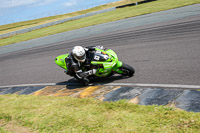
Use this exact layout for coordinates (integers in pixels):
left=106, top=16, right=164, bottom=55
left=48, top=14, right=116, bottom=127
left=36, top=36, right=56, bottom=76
left=0, top=95, right=200, bottom=133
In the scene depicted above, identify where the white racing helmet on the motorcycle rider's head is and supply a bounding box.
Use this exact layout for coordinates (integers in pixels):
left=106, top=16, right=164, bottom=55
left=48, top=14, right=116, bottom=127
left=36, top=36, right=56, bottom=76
left=72, top=46, right=86, bottom=62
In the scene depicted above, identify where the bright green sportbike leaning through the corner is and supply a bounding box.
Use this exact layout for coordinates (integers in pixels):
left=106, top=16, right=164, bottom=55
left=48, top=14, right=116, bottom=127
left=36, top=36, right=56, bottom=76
left=55, top=48, right=135, bottom=85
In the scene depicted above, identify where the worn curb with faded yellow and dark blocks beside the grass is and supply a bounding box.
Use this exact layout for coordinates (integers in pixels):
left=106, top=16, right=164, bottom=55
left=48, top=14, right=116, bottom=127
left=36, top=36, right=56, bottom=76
left=0, top=85, right=200, bottom=112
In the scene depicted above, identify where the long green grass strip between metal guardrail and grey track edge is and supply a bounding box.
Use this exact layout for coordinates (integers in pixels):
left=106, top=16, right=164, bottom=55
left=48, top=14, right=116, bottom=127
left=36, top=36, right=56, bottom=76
left=0, top=0, right=200, bottom=46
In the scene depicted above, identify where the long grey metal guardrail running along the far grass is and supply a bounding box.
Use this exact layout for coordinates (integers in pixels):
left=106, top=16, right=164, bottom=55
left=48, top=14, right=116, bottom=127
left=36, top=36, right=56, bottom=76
left=0, top=7, right=116, bottom=38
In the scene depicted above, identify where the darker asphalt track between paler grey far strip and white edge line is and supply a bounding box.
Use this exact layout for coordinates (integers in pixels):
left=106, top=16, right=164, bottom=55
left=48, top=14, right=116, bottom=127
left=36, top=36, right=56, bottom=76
left=0, top=4, right=200, bottom=86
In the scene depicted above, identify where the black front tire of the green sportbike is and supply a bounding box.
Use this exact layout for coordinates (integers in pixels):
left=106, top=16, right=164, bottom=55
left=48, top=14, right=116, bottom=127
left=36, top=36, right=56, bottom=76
left=120, top=63, right=135, bottom=77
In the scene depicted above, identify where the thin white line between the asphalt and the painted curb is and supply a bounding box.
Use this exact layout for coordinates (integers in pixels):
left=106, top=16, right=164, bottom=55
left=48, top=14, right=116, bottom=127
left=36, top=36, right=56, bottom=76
left=0, top=83, right=200, bottom=89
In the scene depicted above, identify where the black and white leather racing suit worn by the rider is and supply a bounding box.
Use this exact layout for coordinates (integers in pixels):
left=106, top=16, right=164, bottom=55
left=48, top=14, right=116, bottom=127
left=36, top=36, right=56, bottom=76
left=66, top=46, right=109, bottom=82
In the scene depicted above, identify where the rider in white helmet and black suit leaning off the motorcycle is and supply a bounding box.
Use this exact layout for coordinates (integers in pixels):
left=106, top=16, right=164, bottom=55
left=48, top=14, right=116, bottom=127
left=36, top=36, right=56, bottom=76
left=66, top=46, right=109, bottom=85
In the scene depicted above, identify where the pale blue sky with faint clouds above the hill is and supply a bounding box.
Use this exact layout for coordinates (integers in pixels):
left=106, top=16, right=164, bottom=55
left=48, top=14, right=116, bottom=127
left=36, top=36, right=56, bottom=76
left=0, top=0, right=119, bottom=25
